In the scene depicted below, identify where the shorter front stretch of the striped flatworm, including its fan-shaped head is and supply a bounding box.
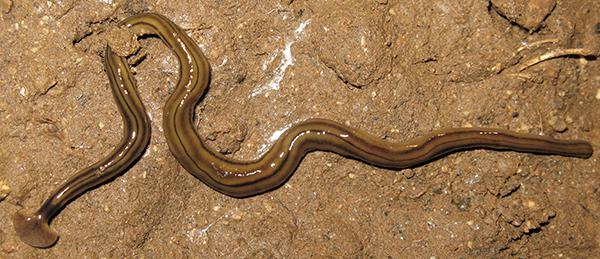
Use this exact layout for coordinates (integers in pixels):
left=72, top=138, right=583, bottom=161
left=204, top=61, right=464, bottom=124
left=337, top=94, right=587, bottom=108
left=13, top=47, right=150, bottom=248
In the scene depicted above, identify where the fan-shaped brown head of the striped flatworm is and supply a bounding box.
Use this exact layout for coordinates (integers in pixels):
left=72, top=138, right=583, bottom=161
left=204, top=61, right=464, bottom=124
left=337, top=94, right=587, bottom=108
left=13, top=211, right=58, bottom=248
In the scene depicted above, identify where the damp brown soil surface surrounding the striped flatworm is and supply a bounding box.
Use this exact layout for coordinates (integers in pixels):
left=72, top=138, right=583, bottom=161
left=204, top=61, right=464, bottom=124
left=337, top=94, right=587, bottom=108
left=0, top=0, right=600, bottom=258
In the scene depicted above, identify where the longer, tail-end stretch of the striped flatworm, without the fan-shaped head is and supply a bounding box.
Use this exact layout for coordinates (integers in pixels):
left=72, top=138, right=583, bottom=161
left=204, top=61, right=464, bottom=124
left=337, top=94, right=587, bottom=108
left=123, top=14, right=592, bottom=198
